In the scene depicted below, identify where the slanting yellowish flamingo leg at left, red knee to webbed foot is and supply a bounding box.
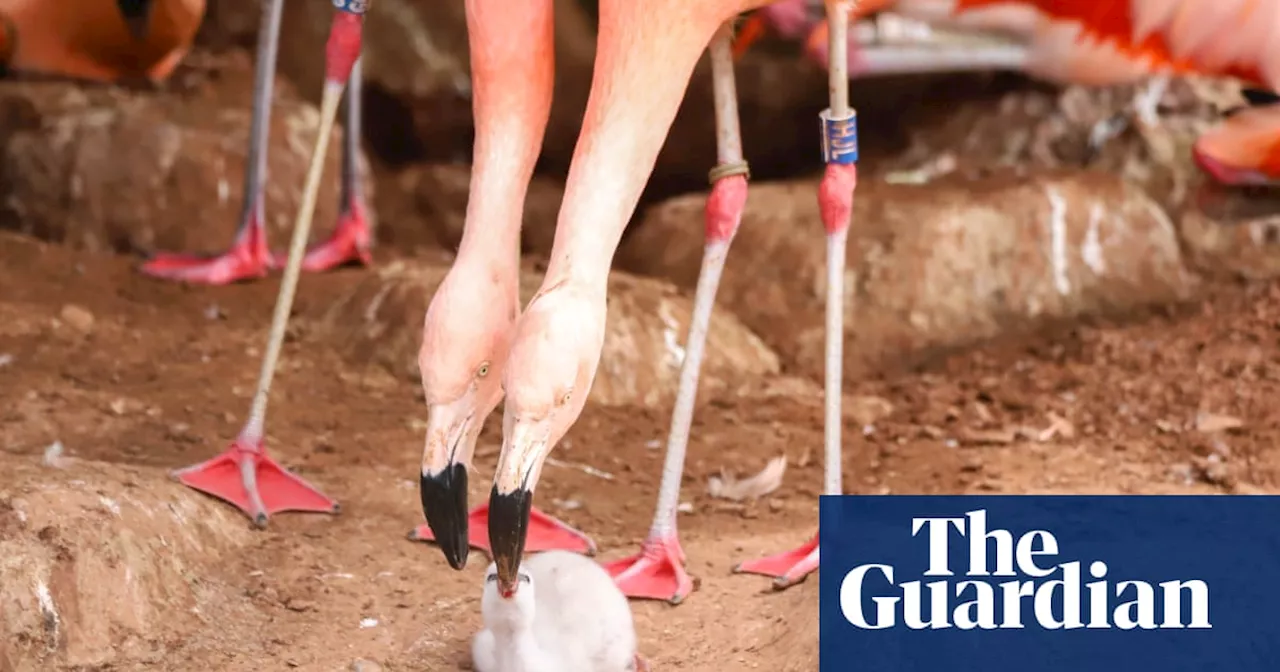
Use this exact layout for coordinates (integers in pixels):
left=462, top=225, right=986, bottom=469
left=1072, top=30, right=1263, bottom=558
left=173, top=5, right=364, bottom=527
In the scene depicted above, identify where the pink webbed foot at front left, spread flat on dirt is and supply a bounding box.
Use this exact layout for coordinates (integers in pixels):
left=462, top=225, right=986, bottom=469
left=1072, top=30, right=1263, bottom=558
left=173, top=439, right=339, bottom=527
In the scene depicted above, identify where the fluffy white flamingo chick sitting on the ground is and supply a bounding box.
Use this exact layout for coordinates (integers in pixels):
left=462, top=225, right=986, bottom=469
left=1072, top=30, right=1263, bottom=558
left=471, top=550, right=648, bottom=672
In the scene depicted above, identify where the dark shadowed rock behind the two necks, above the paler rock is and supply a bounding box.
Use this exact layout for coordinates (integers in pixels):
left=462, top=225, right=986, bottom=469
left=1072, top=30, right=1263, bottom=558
left=388, top=164, right=564, bottom=256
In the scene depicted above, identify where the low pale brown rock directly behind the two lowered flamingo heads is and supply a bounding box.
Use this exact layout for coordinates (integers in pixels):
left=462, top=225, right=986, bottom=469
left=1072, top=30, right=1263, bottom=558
left=319, top=259, right=778, bottom=407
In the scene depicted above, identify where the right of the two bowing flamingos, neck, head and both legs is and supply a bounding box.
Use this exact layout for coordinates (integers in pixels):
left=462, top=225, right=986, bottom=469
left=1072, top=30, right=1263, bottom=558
left=424, top=0, right=856, bottom=602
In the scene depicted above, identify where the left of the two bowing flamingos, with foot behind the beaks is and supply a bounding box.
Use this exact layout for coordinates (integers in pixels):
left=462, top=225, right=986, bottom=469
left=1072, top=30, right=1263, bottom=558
left=410, top=0, right=595, bottom=570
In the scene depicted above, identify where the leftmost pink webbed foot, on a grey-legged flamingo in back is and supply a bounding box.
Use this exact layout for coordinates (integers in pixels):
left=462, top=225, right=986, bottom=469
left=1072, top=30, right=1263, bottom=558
left=138, top=215, right=274, bottom=284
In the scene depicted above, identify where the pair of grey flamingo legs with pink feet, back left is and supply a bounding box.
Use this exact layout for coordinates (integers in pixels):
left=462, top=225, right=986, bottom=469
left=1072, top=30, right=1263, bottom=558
left=137, top=0, right=371, bottom=285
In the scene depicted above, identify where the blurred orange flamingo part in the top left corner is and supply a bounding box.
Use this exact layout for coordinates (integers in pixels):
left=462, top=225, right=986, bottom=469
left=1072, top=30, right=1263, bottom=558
left=0, top=0, right=205, bottom=82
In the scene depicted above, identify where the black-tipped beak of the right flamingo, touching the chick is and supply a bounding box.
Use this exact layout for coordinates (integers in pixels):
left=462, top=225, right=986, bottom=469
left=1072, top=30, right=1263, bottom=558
left=489, top=416, right=552, bottom=594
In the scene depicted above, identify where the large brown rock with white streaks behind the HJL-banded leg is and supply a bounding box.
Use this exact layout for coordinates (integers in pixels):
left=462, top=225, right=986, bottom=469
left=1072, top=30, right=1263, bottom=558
left=618, top=174, right=1193, bottom=376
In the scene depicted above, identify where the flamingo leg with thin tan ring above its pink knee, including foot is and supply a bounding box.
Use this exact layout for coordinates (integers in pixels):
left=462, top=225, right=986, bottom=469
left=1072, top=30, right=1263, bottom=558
left=605, top=20, right=748, bottom=604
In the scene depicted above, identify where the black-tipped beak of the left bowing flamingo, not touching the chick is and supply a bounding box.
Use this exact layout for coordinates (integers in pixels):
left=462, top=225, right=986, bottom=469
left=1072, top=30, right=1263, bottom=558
left=419, top=396, right=476, bottom=570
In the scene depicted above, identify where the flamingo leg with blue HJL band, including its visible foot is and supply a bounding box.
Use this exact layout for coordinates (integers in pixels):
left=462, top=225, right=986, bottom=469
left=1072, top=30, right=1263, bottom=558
left=733, top=0, right=858, bottom=590
